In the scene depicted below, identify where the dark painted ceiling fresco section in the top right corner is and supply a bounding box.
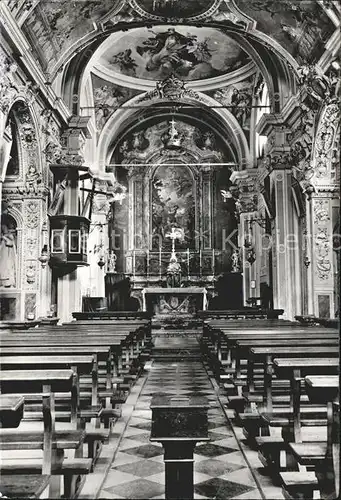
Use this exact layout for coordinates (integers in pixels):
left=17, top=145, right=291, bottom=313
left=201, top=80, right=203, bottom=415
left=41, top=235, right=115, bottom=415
left=234, top=0, right=336, bottom=64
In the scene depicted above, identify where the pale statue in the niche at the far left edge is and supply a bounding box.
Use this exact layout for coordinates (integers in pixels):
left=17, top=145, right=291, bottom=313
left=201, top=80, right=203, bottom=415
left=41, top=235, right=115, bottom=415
left=0, top=223, right=17, bottom=288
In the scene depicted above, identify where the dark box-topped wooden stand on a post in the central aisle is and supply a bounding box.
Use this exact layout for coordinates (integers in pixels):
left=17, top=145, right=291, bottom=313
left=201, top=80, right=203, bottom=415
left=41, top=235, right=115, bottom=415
left=150, top=395, right=210, bottom=500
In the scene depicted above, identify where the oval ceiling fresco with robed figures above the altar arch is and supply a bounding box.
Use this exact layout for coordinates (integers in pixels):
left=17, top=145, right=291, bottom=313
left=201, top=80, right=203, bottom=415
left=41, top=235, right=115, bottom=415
left=99, top=26, right=251, bottom=80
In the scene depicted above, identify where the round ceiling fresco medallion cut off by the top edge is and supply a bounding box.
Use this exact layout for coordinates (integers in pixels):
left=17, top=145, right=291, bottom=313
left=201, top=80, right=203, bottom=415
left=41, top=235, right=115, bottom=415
left=132, top=0, right=220, bottom=18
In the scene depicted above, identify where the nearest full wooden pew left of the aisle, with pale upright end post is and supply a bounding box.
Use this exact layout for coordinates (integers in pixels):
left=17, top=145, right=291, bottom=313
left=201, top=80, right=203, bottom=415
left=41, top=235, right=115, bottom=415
left=0, top=370, right=91, bottom=497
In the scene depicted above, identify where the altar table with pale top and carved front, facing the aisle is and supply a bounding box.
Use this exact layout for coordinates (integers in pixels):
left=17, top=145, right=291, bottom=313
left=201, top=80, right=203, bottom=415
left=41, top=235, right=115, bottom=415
left=142, top=287, right=207, bottom=315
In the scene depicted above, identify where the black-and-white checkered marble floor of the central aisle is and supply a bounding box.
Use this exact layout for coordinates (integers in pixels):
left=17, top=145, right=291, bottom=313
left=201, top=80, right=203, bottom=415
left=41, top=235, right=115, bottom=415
left=98, top=361, right=262, bottom=500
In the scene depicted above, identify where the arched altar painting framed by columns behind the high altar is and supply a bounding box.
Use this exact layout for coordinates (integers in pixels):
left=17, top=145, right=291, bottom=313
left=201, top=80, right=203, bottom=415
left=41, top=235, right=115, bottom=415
left=152, top=165, right=195, bottom=250
